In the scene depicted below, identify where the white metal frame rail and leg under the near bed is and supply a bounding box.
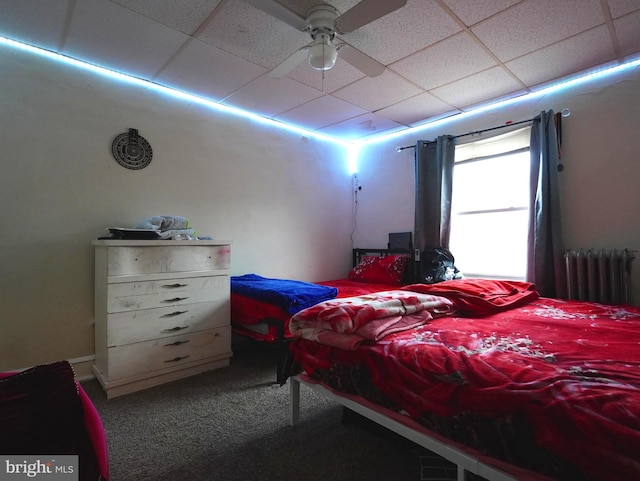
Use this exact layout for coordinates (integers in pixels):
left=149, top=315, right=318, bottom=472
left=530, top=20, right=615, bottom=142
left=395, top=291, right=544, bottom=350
left=289, top=376, right=518, bottom=481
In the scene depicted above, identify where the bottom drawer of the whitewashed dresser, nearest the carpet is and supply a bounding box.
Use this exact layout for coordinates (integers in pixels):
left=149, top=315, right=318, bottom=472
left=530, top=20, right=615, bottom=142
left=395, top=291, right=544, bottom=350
left=107, top=326, right=231, bottom=379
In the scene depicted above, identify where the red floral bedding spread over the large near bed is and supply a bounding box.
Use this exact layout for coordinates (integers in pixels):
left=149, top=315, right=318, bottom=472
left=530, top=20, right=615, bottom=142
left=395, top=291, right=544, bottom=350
left=291, top=281, right=640, bottom=481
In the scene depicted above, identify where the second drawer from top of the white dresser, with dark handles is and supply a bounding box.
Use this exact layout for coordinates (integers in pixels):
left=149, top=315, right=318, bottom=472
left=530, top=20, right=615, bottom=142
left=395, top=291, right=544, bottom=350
left=107, top=276, right=229, bottom=313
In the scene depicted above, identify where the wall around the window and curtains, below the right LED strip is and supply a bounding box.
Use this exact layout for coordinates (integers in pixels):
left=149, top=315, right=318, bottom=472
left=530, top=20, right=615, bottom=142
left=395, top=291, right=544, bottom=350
left=355, top=68, right=640, bottom=305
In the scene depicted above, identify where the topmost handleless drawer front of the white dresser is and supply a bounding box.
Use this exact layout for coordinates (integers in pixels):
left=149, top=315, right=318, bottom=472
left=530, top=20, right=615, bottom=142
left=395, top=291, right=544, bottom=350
left=107, top=241, right=231, bottom=276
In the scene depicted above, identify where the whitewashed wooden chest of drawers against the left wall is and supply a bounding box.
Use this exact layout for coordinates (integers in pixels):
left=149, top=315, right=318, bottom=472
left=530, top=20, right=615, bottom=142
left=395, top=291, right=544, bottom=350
left=93, top=240, right=232, bottom=398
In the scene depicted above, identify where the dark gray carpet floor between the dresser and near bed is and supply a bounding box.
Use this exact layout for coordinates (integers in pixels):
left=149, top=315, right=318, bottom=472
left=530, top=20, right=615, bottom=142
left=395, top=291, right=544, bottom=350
left=83, top=340, right=455, bottom=481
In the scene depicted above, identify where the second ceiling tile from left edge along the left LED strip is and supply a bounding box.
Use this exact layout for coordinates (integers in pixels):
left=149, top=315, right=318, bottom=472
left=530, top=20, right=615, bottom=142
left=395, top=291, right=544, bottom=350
left=63, top=0, right=189, bottom=78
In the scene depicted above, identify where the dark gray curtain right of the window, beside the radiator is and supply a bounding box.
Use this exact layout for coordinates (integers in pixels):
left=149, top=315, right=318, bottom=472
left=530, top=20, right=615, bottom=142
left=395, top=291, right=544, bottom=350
left=527, top=110, right=566, bottom=298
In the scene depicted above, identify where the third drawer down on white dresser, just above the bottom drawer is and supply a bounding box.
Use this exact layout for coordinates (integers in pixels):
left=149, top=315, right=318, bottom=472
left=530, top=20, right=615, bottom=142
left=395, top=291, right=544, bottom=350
left=107, top=298, right=229, bottom=347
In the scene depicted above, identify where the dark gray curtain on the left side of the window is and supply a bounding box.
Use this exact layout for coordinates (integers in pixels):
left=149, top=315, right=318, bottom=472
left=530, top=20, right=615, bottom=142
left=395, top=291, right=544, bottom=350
left=414, top=135, right=455, bottom=251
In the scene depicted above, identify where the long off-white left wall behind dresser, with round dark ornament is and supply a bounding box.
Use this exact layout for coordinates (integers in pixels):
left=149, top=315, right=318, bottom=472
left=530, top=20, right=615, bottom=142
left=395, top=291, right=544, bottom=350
left=0, top=43, right=353, bottom=374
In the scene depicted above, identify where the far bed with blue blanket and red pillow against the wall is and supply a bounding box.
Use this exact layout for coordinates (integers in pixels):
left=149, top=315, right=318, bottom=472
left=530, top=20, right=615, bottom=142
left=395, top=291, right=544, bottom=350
left=231, top=248, right=419, bottom=383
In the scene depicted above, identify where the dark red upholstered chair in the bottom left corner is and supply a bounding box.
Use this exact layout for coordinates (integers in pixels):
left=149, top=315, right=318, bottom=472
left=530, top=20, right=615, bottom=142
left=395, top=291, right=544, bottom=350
left=0, top=361, right=109, bottom=481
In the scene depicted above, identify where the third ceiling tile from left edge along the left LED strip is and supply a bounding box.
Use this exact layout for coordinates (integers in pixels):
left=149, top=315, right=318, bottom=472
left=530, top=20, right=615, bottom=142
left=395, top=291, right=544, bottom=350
left=156, top=40, right=265, bottom=100
